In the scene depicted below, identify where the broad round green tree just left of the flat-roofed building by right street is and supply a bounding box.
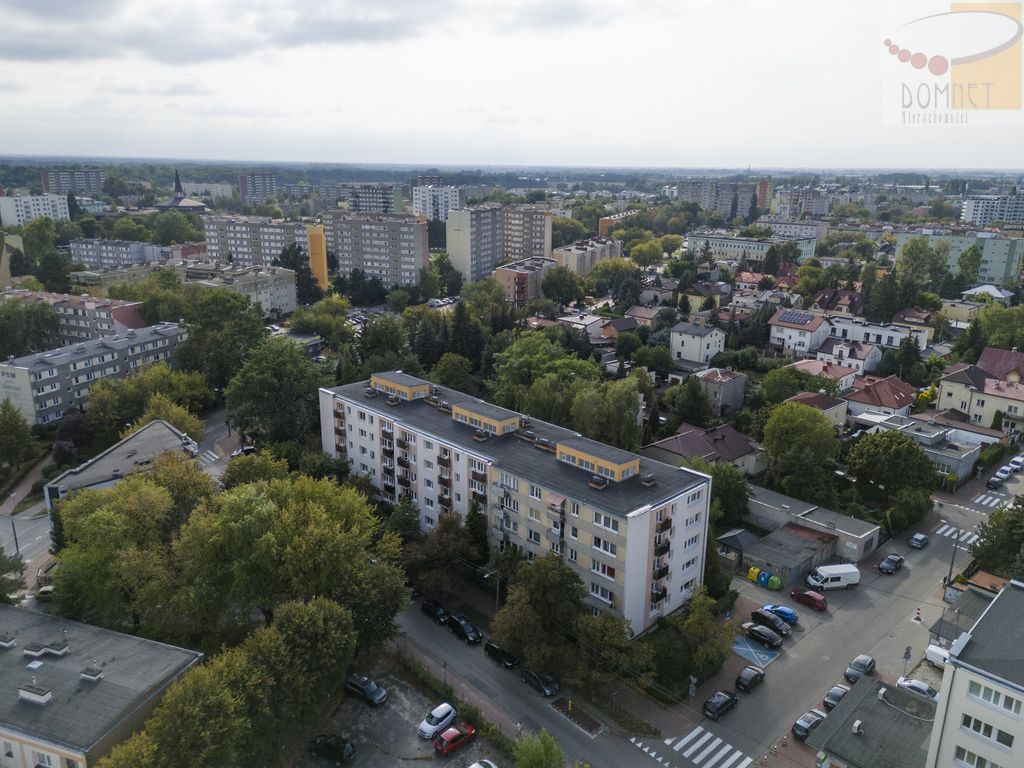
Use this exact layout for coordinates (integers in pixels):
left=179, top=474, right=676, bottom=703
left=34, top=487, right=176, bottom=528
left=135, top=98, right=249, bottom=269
left=846, top=430, right=936, bottom=497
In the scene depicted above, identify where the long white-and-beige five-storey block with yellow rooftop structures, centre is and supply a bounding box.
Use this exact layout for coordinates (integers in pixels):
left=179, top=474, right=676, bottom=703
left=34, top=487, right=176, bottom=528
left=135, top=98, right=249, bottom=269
left=319, top=372, right=711, bottom=633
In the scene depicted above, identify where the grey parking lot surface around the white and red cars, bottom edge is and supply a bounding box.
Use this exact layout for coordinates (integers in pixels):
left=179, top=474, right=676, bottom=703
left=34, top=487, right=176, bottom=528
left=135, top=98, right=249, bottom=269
left=295, top=663, right=492, bottom=768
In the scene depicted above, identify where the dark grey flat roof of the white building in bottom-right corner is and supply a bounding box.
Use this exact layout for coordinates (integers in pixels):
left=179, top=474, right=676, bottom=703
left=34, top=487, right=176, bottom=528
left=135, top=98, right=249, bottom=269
left=952, top=581, right=1024, bottom=690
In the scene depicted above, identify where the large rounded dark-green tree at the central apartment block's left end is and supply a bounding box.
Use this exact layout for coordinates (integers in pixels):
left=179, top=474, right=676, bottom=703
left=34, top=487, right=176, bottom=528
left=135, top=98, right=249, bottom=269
left=224, top=337, right=331, bottom=440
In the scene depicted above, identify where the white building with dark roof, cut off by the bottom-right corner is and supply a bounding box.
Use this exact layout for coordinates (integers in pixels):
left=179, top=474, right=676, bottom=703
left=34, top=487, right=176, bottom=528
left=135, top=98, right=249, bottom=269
left=925, top=581, right=1024, bottom=768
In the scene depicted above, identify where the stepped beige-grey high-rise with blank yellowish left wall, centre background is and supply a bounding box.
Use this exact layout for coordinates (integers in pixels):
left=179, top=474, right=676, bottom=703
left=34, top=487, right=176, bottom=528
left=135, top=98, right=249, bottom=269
left=445, top=205, right=551, bottom=283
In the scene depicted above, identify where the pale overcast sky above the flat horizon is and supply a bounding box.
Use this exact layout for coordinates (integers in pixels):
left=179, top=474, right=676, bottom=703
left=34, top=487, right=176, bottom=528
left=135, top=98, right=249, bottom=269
left=6, top=0, right=1024, bottom=169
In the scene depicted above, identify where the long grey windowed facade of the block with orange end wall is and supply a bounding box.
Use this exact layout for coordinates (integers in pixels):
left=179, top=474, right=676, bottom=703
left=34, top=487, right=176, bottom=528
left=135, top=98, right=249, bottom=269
left=203, top=216, right=309, bottom=266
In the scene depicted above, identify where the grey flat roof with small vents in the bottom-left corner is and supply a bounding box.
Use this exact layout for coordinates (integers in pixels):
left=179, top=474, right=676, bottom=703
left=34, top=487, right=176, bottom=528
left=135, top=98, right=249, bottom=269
left=0, top=604, right=202, bottom=751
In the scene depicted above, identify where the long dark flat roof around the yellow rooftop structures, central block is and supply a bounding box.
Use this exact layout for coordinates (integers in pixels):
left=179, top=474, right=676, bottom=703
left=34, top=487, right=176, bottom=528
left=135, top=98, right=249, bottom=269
left=326, top=377, right=707, bottom=516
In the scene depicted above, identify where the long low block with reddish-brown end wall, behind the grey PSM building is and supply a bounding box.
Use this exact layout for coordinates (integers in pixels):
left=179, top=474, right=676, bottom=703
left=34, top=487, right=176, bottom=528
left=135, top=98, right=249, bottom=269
left=0, top=289, right=145, bottom=346
